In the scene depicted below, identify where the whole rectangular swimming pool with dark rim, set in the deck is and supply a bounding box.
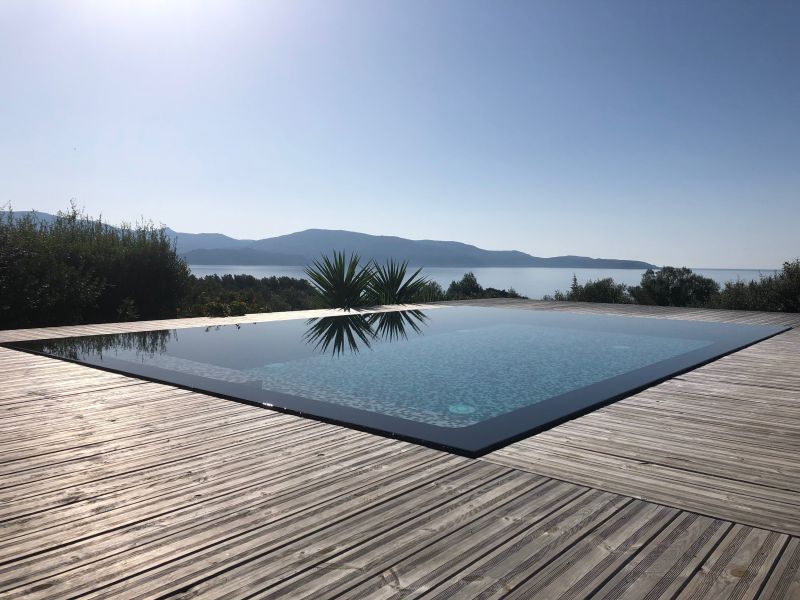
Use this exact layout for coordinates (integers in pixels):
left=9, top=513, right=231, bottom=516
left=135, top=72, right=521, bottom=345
left=5, top=306, right=785, bottom=456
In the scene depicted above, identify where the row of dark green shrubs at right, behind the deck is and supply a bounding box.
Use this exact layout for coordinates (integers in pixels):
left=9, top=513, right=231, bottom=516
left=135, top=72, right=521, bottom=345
left=545, top=259, right=800, bottom=312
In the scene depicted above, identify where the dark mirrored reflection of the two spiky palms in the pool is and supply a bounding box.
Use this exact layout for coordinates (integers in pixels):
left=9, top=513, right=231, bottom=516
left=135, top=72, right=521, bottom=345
left=303, top=310, right=428, bottom=356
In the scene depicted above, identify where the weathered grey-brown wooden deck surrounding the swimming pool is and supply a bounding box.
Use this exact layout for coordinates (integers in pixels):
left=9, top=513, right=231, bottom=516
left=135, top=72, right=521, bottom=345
left=0, top=302, right=800, bottom=600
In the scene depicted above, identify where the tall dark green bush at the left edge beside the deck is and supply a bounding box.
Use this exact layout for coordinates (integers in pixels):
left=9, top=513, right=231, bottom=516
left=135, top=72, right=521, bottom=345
left=0, top=206, right=189, bottom=328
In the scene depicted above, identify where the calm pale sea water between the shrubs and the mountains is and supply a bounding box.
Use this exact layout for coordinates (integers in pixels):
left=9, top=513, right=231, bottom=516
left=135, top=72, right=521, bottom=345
left=190, top=265, right=775, bottom=298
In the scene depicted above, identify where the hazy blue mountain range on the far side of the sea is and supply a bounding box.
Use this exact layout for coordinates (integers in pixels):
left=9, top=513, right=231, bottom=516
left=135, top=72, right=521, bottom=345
left=4, top=211, right=657, bottom=269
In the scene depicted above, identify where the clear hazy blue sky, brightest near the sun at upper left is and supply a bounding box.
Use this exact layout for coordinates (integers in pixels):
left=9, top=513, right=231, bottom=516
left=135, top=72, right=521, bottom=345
left=0, top=0, right=800, bottom=267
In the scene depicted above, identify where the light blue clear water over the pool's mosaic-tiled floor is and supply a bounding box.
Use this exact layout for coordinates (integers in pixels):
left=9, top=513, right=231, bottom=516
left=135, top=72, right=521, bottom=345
left=243, top=324, right=709, bottom=427
